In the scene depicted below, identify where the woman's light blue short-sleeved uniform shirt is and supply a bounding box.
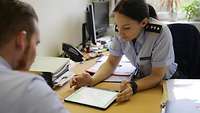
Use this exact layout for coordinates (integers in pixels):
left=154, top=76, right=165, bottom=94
left=109, top=18, right=177, bottom=79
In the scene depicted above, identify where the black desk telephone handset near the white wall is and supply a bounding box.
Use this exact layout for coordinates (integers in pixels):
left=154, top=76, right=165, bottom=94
left=62, top=43, right=83, bottom=62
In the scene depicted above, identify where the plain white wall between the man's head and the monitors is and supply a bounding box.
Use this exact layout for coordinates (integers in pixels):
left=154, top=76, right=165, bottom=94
left=22, top=0, right=88, bottom=56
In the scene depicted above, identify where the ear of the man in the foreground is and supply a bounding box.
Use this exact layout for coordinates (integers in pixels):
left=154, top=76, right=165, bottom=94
left=16, top=31, right=27, bottom=50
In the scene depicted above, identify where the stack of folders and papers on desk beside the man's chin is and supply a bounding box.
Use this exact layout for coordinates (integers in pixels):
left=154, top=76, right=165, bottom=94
left=30, top=56, right=72, bottom=85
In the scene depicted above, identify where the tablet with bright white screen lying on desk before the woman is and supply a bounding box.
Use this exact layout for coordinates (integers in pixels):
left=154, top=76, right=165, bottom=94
left=64, top=87, right=118, bottom=109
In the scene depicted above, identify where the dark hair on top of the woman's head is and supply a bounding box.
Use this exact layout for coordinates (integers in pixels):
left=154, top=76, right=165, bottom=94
left=114, top=0, right=149, bottom=22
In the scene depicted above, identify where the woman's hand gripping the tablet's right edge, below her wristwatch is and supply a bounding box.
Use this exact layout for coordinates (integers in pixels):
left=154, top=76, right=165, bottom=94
left=116, top=81, right=133, bottom=102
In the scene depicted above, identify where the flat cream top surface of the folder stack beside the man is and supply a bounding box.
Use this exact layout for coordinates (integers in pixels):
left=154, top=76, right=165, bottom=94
left=30, top=56, right=70, bottom=73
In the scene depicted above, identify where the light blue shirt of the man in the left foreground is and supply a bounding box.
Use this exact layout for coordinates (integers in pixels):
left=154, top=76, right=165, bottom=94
left=0, top=57, right=69, bottom=113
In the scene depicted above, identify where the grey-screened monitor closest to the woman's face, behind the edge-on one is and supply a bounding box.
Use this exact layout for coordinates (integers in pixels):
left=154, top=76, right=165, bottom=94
left=92, top=0, right=109, bottom=38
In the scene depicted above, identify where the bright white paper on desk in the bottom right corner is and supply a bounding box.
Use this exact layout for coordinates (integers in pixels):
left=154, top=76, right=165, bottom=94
left=166, top=79, right=200, bottom=113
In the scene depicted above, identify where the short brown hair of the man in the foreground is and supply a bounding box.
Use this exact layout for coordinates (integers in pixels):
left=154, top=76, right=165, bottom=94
left=0, top=0, right=38, bottom=46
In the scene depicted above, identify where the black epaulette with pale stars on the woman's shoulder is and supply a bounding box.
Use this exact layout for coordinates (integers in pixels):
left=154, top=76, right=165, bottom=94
left=145, top=23, right=162, bottom=33
